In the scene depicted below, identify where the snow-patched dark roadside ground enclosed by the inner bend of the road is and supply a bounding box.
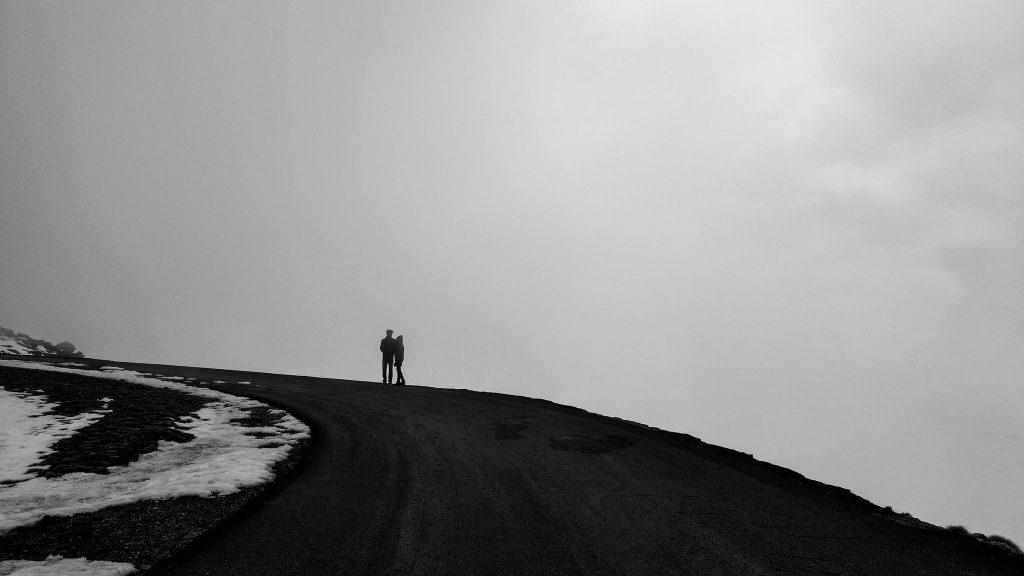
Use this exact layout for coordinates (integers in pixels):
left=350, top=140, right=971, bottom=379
left=0, top=359, right=309, bottom=576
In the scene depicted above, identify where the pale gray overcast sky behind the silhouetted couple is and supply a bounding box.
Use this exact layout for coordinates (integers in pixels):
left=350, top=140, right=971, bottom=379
left=0, top=0, right=1024, bottom=544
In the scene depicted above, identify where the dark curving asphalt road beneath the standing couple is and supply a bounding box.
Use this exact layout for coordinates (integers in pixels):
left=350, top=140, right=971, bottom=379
left=79, top=363, right=1022, bottom=576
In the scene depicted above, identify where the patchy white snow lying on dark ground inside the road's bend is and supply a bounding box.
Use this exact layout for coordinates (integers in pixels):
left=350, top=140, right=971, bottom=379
left=0, top=360, right=309, bottom=576
